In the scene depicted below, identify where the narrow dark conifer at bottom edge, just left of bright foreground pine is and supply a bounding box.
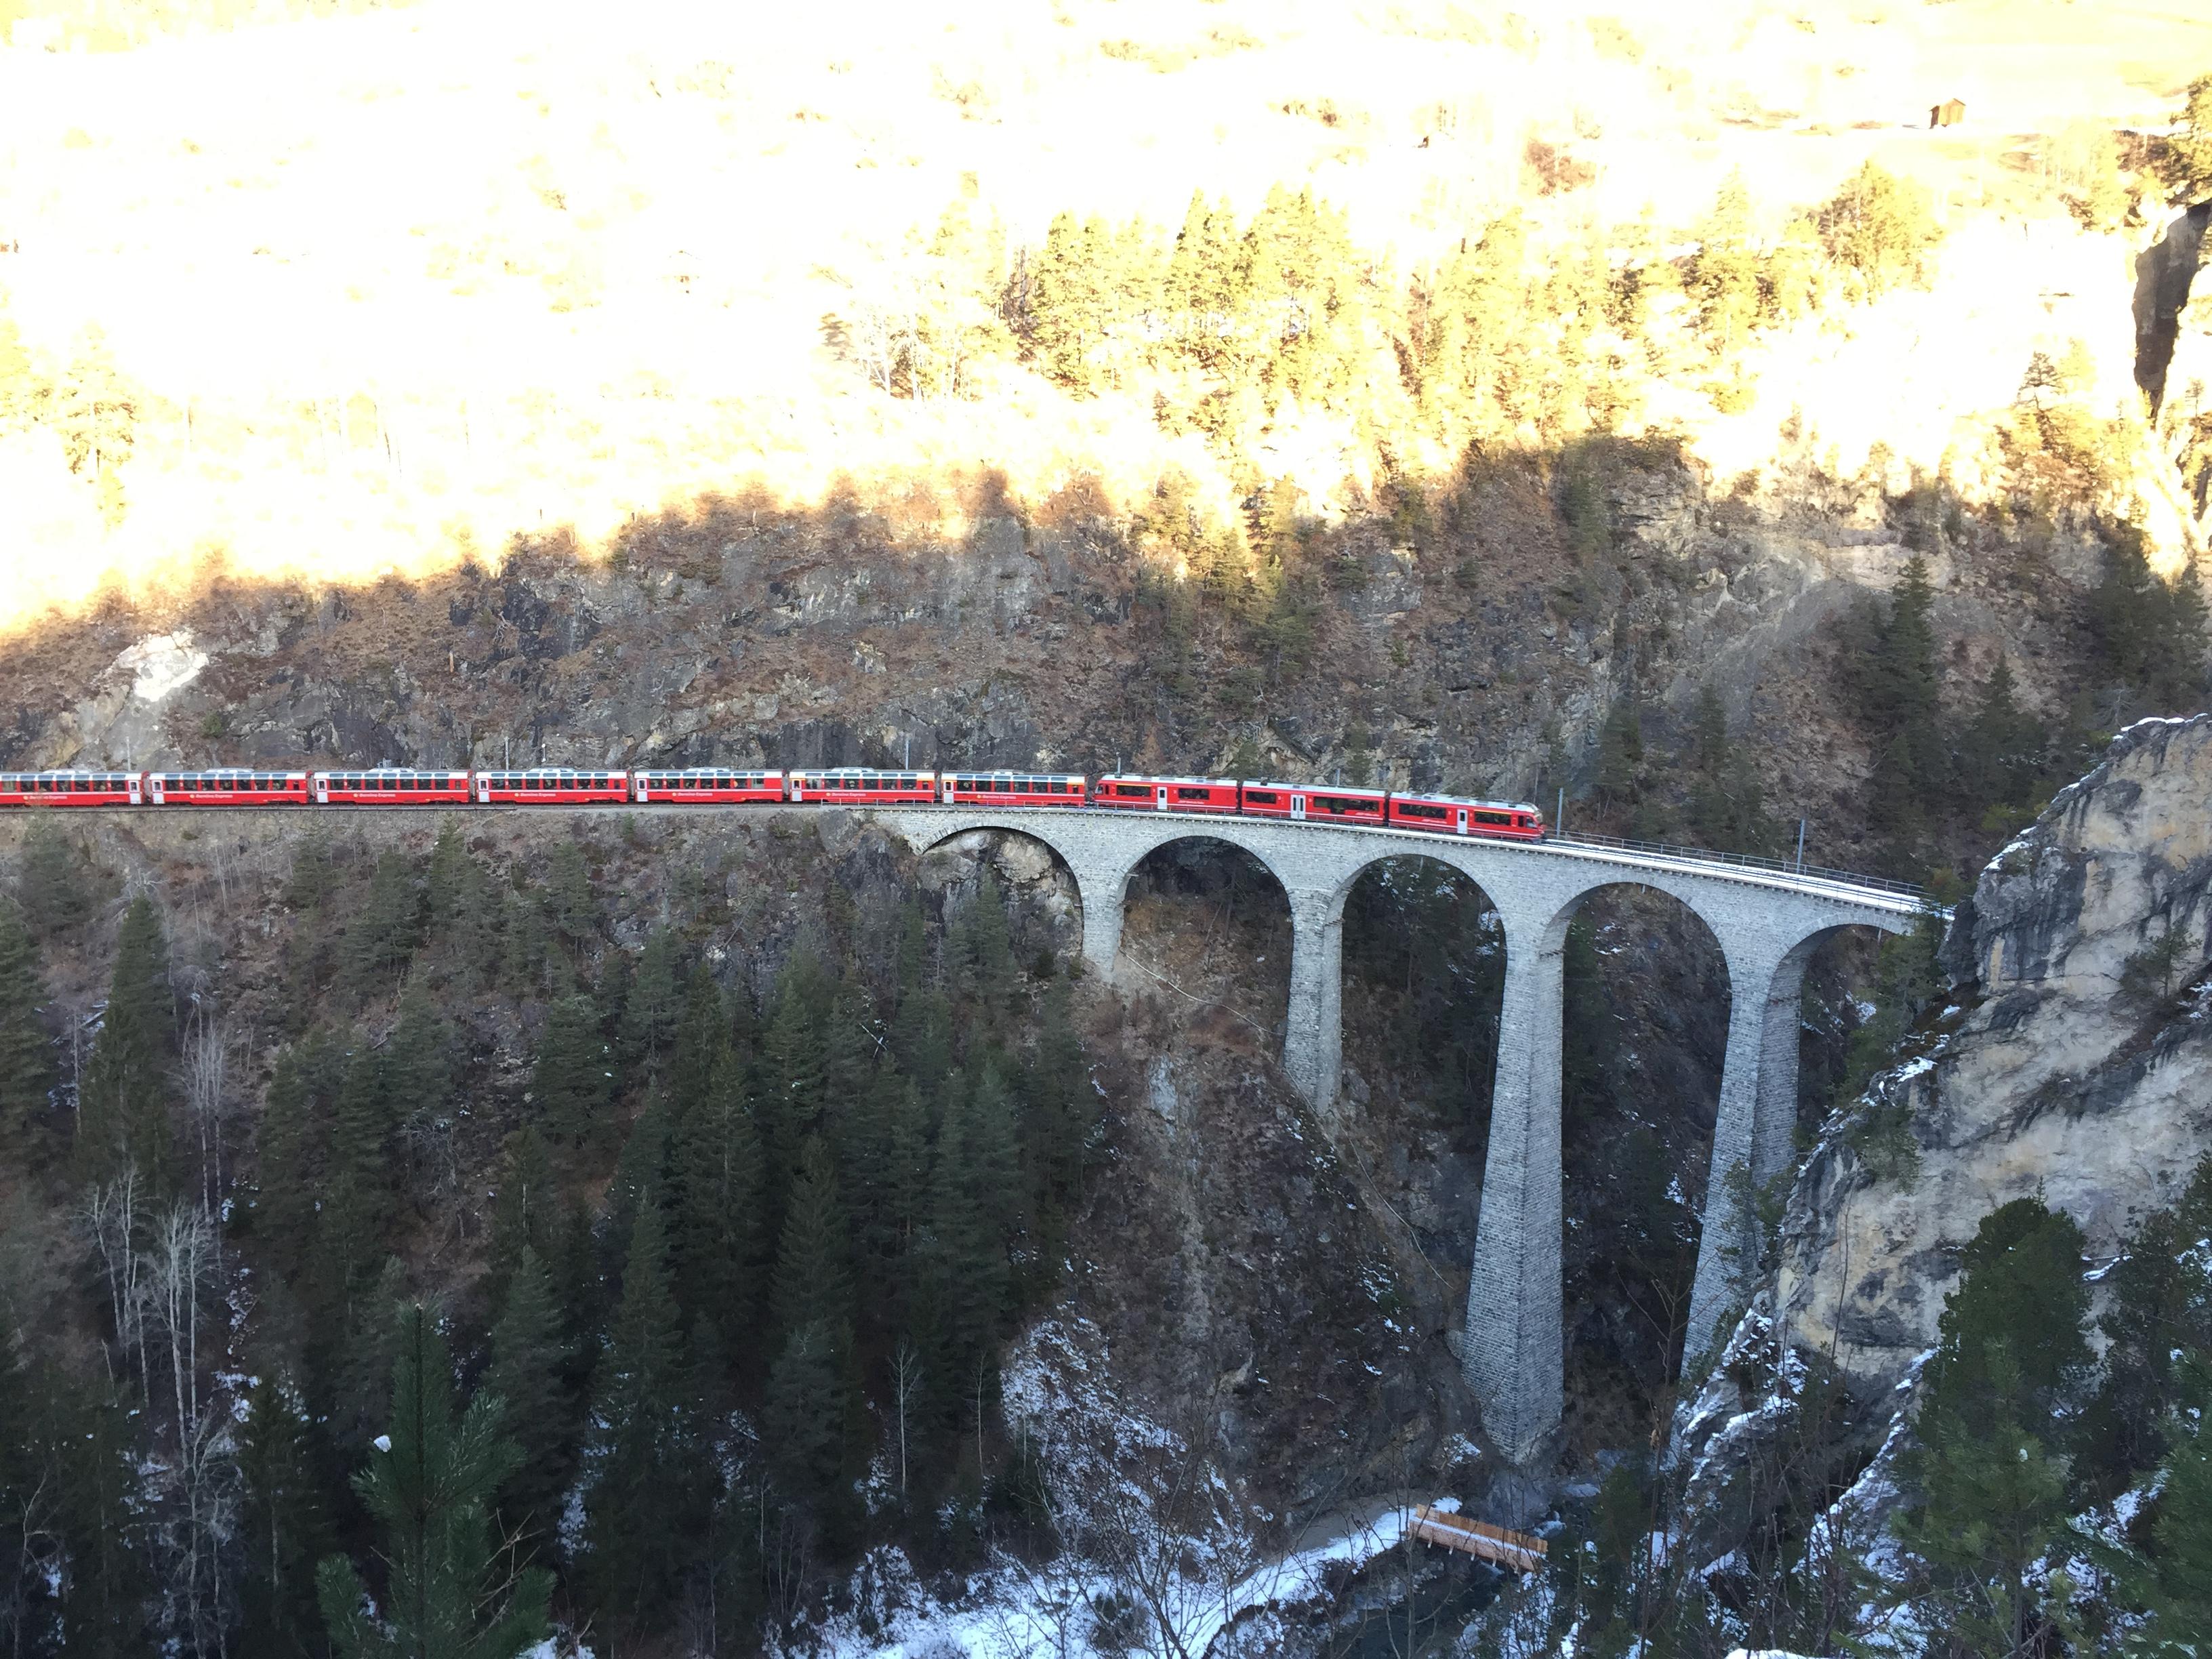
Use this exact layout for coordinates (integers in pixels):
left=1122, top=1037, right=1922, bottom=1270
left=239, top=1374, right=332, bottom=1659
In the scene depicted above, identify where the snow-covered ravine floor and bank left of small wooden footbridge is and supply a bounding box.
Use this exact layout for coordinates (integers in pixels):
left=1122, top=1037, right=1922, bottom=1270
left=783, top=1318, right=1458, bottom=1659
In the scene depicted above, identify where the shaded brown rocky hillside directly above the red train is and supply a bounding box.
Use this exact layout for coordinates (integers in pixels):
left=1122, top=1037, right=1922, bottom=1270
left=0, top=453, right=2097, bottom=863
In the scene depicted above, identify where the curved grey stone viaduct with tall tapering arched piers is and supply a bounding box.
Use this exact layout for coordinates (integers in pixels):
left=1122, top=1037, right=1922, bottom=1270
left=867, top=807, right=1920, bottom=1465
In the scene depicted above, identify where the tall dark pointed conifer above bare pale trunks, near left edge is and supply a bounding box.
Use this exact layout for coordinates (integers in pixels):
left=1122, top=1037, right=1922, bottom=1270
left=77, top=894, right=177, bottom=1192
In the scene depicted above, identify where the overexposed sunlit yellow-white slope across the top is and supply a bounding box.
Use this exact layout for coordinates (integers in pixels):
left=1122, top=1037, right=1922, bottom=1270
left=0, top=0, right=2212, bottom=617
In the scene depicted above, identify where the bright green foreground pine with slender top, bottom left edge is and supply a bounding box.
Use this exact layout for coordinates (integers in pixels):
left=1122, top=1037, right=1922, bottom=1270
left=316, top=1305, right=553, bottom=1659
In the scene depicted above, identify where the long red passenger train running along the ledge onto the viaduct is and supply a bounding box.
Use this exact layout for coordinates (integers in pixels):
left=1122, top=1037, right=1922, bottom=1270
left=0, top=765, right=1544, bottom=840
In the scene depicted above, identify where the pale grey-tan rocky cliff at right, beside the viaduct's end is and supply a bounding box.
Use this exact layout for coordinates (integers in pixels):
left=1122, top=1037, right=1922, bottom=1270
left=1776, top=714, right=2212, bottom=1398
